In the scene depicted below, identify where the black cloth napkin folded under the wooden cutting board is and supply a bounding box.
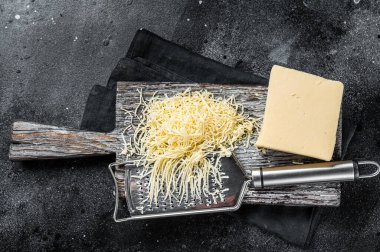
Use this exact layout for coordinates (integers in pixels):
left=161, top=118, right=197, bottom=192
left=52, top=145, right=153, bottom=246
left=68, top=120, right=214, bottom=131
left=81, top=29, right=354, bottom=247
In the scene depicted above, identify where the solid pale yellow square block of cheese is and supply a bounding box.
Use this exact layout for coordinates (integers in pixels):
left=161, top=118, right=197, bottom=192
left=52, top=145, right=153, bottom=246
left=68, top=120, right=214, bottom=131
left=256, top=65, right=343, bottom=161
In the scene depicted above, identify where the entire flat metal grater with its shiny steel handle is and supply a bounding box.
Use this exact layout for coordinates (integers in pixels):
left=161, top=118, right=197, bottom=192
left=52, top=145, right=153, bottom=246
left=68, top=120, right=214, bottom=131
left=109, top=157, right=380, bottom=222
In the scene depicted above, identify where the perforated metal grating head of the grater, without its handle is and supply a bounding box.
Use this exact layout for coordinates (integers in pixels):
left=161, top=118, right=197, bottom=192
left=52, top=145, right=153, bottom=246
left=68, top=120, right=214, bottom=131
left=109, top=158, right=250, bottom=222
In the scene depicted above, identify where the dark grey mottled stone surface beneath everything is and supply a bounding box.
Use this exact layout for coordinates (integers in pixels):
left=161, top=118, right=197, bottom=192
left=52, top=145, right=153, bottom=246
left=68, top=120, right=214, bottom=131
left=0, top=0, right=380, bottom=251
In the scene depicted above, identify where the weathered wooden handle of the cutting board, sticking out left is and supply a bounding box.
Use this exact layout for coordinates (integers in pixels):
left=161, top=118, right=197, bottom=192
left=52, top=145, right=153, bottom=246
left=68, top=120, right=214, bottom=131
left=9, top=122, right=121, bottom=160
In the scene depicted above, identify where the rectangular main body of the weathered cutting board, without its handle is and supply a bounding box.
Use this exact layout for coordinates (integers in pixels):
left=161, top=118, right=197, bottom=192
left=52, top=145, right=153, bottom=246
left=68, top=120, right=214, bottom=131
left=116, top=82, right=341, bottom=206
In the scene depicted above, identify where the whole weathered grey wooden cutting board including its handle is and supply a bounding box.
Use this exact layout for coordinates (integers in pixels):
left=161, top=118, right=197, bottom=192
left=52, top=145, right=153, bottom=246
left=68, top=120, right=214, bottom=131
left=9, top=82, right=341, bottom=206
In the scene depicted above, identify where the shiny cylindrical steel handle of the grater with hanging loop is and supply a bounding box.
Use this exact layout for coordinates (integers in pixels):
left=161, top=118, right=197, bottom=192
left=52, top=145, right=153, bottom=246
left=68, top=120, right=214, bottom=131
left=251, top=161, right=380, bottom=188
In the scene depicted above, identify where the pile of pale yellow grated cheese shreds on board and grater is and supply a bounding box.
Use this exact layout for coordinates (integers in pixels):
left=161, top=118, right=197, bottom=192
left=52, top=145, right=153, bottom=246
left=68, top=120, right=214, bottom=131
left=121, top=89, right=256, bottom=203
